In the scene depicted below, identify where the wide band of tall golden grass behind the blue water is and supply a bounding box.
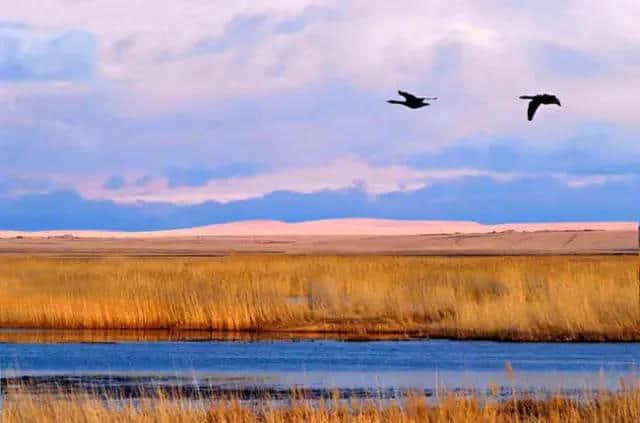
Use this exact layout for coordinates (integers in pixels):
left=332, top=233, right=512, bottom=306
left=0, top=256, right=640, bottom=340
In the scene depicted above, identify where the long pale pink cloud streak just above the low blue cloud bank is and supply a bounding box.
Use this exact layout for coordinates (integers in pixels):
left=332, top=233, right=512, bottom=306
left=56, top=159, right=517, bottom=204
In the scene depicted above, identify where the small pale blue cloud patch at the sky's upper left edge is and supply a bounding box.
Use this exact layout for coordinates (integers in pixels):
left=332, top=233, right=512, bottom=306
left=0, top=23, right=96, bottom=81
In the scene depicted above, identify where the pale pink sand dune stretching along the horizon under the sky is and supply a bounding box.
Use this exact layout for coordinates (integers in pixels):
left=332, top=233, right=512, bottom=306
left=0, top=219, right=638, bottom=238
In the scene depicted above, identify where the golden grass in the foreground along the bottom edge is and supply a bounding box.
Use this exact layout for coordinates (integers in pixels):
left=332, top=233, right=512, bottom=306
left=0, top=388, right=640, bottom=423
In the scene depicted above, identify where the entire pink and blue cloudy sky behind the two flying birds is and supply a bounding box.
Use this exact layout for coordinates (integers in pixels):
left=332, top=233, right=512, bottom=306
left=0, top=0, right=640, bottom=230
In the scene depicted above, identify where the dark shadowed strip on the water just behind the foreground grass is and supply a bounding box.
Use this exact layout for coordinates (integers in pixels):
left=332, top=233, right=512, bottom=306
left=0, top=375, right=600, bottom=401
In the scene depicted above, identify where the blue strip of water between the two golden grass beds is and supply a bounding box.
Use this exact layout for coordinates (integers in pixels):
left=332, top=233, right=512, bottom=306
left=0, top=334, right=640, bottom=398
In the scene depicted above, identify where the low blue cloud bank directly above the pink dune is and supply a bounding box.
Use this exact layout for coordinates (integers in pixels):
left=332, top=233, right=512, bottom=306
left=0, top=177, right=640, bottom=230
